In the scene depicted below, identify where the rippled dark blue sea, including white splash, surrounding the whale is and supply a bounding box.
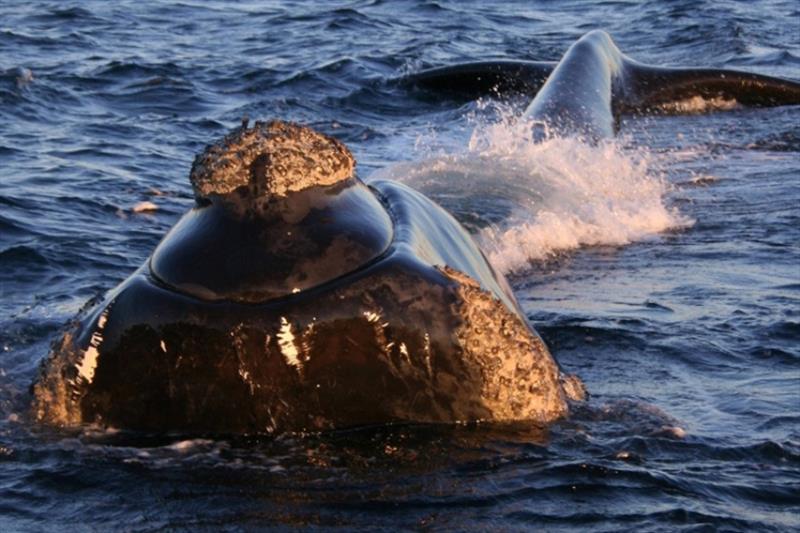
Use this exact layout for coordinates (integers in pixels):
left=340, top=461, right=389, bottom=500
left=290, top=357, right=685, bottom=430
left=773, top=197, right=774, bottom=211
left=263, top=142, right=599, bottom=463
left=0, top=0, right=800, bottom=531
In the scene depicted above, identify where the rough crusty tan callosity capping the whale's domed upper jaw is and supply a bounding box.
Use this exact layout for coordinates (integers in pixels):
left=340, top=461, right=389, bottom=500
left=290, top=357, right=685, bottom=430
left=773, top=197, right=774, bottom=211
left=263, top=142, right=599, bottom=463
left=189, top=120, right=355, bottom=203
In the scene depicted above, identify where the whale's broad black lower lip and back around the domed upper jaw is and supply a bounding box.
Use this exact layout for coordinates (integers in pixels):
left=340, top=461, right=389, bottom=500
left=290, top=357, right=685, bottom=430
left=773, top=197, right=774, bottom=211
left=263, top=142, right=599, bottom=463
left=34, top=182, right=566, bottom=433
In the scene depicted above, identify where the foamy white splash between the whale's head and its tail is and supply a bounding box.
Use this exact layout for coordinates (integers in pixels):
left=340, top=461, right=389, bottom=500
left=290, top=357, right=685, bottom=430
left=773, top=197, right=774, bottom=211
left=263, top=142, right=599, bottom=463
left=378, top=108, right=692, bottom=272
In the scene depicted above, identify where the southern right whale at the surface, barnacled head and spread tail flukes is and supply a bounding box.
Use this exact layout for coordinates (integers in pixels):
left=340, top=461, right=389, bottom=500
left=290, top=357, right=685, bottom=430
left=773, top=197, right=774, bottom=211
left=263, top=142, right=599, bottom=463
left=33, top=32, right=800, bottom=433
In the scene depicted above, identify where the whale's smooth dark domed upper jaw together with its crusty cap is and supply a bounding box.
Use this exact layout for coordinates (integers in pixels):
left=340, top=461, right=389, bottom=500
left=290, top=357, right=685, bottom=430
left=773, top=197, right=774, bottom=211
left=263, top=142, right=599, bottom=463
left=150, top=121, right=392, bottom=303
